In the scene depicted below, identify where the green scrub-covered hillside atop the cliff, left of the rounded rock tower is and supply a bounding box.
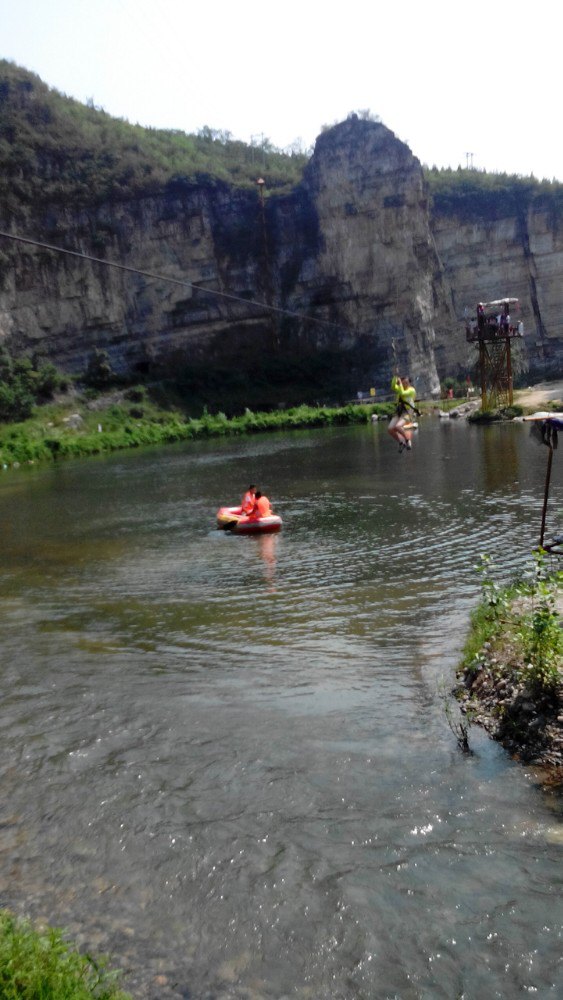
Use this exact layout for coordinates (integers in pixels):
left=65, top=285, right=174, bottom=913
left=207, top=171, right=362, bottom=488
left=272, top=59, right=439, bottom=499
left=0, top=60, right=309, bottom=214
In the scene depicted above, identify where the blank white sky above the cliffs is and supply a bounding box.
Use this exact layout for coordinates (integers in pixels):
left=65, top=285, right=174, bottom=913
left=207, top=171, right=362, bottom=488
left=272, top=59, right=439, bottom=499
left=0, top=0, right=563, bottom=181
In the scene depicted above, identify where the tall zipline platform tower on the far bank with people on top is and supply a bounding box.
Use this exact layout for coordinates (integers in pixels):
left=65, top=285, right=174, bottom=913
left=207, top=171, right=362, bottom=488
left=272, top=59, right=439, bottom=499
left=466, top=298, right=524, bottom=410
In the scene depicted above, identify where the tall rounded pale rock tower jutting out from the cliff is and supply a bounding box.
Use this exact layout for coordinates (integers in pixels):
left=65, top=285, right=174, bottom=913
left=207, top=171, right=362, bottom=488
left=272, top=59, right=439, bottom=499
left=288, top=119, right=446, bottom=395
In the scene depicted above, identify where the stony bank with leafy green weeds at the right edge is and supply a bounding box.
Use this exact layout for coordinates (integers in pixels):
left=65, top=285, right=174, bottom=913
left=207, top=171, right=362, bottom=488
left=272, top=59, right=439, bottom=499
left=456, top=554, right=563, bottom=782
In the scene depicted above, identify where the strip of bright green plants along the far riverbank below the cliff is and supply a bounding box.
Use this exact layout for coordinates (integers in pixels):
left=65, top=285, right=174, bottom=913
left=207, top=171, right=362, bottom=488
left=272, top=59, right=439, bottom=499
left=0, top=390, right=393, bottom=468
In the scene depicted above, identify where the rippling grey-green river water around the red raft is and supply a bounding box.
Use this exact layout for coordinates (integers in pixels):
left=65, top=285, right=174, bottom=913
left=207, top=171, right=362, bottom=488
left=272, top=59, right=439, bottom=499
left=0, top=418, right=563, bottom=1000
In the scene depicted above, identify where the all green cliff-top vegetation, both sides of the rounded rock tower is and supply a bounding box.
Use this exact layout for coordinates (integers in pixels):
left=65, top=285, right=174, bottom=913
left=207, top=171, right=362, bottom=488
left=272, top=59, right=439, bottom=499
left=0, top=60, right=563, bottom=220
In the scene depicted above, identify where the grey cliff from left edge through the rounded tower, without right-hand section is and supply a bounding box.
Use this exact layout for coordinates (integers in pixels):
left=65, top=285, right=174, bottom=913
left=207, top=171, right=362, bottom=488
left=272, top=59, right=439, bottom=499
left=0, top=119, right=447, bottom=394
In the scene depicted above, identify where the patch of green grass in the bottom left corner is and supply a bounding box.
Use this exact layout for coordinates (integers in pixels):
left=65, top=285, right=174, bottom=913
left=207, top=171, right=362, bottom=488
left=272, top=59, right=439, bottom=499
left=0, top=911, right=130, bottom=1000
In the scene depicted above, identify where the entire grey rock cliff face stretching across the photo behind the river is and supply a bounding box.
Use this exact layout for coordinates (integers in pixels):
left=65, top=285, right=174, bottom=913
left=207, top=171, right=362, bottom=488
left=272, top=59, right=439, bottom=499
left=0, top=94, right=563, bottom=398
